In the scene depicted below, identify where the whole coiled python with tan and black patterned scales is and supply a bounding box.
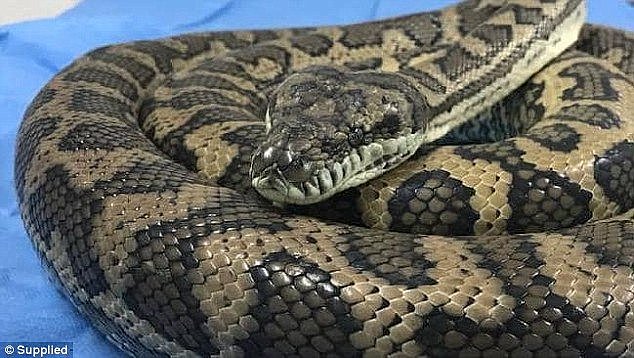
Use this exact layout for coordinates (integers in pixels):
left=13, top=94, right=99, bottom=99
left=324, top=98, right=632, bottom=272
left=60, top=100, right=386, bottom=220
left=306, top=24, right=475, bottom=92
left=14, top=0, right=634, bottom=357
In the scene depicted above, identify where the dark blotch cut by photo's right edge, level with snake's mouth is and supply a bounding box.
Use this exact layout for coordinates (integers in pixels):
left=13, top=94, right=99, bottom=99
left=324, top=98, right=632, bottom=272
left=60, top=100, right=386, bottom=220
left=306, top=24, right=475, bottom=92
left=594, top=140, right=634, bottom=212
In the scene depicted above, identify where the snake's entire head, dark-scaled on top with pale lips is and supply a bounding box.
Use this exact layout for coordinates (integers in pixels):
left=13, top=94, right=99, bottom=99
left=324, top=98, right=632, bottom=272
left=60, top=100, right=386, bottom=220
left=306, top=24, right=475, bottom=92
left=251, top=67, right=424, bottom=204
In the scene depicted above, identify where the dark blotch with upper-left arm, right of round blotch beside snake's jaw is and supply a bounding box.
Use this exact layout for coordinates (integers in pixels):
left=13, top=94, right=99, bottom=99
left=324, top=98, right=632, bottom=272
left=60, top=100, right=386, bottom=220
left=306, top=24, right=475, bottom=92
left=454, top=139, right=592, bottom=233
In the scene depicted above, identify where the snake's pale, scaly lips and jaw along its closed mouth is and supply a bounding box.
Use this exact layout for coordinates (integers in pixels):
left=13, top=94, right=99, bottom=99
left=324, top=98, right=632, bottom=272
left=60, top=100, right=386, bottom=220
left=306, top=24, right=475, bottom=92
left=251, top=134, right=420, bottom=205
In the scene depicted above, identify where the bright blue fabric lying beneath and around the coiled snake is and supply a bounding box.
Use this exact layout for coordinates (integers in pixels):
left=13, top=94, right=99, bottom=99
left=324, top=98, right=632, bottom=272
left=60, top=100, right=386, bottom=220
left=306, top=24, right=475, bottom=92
left=0, top=0, right=634, bottom=357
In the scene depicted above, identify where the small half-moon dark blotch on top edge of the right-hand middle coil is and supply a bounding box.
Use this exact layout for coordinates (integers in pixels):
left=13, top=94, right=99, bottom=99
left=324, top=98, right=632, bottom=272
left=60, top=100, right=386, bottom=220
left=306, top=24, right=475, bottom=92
left=551, top=104, right=621, bottom=129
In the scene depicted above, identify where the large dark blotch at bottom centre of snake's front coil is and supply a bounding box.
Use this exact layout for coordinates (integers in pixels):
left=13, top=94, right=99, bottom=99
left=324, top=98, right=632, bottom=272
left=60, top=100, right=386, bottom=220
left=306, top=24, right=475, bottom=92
left=236, top=251, right=363, bottom=357
